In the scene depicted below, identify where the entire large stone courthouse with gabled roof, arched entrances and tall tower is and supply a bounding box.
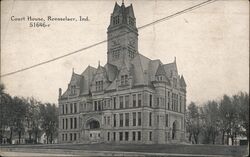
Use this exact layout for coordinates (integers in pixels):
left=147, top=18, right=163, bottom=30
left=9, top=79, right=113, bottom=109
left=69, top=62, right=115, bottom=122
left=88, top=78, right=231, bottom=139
left=58, top=3, right=186, bottom=144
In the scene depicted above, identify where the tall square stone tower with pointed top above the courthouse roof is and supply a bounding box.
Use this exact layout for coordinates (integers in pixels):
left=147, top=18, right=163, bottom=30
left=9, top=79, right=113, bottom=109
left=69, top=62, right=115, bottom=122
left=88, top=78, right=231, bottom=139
left=107, top=3, right=138, bottom=68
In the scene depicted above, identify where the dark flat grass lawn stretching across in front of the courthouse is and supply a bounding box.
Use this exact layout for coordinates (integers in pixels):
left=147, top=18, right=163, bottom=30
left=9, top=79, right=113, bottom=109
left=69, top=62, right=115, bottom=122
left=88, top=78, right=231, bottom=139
left=1, top=144, right=247, bottom=156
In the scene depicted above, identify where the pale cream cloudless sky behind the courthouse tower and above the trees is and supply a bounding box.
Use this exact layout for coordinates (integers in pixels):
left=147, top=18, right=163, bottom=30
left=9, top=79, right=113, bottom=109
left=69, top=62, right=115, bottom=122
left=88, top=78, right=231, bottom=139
left=1, top=0, right=249, bottom=104
